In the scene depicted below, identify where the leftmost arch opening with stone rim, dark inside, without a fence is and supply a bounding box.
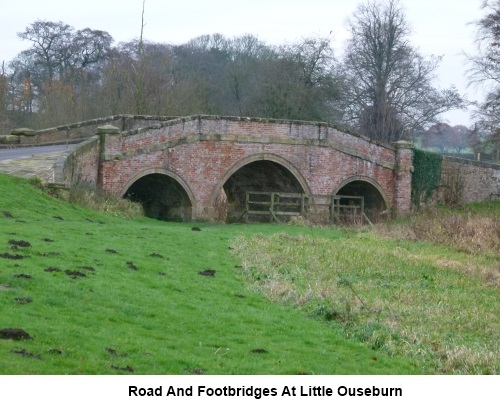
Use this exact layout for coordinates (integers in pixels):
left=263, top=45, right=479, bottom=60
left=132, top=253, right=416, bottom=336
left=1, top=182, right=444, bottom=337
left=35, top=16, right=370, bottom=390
left=121, top=168, right=195, bottom=221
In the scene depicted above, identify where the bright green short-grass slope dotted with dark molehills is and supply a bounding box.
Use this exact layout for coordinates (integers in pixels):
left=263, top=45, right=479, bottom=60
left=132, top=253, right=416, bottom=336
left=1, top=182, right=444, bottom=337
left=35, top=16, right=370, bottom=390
left=0, top=175, right=418, bottom=374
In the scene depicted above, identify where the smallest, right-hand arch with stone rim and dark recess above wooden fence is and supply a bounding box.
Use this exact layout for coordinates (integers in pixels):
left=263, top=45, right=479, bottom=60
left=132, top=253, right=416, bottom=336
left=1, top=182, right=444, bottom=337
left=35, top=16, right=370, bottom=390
left=333, top=176, right=390, bottom=221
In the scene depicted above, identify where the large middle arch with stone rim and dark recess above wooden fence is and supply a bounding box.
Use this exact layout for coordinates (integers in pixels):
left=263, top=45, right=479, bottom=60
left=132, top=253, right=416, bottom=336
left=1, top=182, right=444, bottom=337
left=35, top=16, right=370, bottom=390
left=209, top=153, right=310, bottom=222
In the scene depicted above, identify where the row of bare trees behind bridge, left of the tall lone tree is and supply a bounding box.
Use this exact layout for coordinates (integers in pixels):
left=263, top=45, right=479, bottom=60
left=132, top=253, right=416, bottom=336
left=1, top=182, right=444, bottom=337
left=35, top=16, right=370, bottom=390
left=0, top=28, right=340, bottom=133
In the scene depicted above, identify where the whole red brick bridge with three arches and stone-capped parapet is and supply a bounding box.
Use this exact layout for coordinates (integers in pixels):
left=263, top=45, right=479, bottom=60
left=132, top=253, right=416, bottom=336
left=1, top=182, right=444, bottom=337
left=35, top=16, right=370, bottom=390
left=56, top=116, right=412, bottom=220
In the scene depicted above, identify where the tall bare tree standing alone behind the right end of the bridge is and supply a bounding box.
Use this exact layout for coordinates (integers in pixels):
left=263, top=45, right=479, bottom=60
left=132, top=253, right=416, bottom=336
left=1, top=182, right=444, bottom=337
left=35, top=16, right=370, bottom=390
left=340, top=0, right=464, bottom=143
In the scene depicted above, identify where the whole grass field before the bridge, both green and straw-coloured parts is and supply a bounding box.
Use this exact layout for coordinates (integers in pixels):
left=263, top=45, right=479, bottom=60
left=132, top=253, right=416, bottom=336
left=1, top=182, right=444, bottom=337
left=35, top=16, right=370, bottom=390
left=0, top=176, right=500, bottom=374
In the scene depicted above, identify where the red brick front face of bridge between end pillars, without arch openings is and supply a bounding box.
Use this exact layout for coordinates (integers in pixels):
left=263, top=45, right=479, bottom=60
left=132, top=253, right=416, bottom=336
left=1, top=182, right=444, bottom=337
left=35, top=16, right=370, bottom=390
left=83, top=117, right=412, bottom=219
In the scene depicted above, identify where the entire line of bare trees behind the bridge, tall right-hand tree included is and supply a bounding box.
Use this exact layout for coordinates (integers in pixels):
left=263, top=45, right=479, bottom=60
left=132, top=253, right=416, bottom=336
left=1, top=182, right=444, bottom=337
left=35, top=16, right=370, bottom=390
left=4, top=0, right=500, bottom=152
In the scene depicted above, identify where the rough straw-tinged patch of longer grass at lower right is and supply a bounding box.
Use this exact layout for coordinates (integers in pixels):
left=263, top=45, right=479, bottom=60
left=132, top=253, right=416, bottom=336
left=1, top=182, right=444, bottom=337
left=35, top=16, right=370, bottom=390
left=235, top=226, right=500, bottom=374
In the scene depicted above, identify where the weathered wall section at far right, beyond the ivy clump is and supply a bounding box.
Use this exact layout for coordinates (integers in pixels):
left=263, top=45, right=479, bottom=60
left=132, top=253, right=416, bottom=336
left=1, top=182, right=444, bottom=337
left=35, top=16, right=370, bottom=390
left=441, top=156, right=500, bottom=202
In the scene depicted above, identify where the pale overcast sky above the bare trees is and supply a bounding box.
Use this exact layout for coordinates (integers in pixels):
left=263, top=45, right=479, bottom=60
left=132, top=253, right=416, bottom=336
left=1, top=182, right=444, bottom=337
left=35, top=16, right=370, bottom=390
left=0, top=0, right=482, bottom=125
